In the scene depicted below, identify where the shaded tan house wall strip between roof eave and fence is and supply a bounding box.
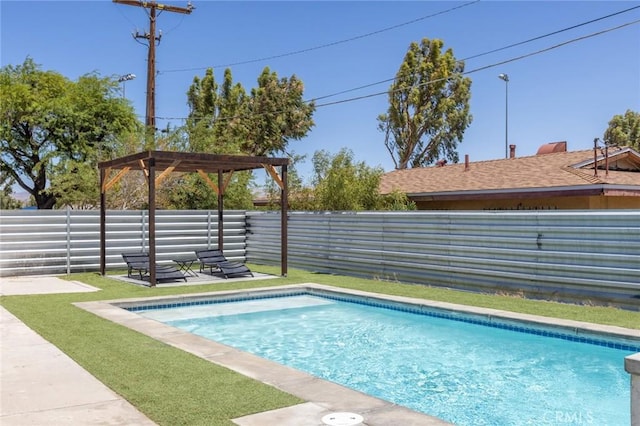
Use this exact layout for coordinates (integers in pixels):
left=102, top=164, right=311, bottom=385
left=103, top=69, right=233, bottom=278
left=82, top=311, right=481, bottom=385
left=416, top=195, right=640, bottom=210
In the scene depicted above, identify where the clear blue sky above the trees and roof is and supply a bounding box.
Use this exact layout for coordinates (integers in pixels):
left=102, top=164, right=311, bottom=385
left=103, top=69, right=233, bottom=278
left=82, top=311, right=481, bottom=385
left=0, top=0, right=640, bottom=182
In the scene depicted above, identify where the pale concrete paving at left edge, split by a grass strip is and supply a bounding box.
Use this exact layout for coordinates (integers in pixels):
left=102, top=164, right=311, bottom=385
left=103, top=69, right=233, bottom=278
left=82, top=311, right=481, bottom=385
left=0, top=276, right=155, bottom=426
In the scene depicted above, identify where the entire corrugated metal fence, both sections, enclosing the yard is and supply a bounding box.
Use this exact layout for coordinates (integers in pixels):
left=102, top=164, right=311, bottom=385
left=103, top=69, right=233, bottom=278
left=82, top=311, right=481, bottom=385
left=0, top=210, right=640, bottom=308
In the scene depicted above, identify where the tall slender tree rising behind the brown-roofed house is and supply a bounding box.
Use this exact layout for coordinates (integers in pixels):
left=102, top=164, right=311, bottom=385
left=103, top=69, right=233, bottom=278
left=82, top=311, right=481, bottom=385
left=378, top=38, right=472, bottom=169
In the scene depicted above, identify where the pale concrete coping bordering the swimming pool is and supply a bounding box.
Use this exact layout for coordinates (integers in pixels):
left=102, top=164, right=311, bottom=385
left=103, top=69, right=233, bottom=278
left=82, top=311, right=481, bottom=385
left=74, top=283, right=640, bottom=426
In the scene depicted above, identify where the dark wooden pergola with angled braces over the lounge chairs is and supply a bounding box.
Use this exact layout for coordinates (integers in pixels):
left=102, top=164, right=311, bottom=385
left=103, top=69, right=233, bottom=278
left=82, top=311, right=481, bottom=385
left=98, top=151, right=289, bottom=286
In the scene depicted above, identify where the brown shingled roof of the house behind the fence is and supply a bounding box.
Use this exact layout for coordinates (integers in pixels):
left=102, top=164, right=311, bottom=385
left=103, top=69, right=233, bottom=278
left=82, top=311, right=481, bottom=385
left=380, top=148, right=640, bottom=196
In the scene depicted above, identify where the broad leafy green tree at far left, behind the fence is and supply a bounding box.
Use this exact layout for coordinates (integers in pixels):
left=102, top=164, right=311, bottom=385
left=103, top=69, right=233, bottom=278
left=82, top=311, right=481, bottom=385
left=0, top=58, right=139, bottom=209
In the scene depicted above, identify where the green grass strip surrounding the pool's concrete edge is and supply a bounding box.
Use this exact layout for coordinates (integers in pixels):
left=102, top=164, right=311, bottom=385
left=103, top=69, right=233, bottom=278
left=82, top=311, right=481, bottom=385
left=0, top=265, right=640, bottom=425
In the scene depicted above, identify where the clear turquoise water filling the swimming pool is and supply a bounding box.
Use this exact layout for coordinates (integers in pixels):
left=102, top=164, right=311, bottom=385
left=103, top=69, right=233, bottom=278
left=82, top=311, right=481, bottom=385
left=138, top=295, right=637, bottom=426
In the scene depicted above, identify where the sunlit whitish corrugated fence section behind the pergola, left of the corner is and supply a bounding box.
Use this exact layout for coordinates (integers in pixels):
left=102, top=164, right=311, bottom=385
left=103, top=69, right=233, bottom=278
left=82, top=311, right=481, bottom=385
left=0, top=210, right=246, bottom=276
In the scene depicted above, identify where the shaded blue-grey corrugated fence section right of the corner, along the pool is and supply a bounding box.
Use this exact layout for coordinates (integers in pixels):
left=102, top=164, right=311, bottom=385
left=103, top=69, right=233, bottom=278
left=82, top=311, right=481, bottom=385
left=247, top=211, right=640, bottom=308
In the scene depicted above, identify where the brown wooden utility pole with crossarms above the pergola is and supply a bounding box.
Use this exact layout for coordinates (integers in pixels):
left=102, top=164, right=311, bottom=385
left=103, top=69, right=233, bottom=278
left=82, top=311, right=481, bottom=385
left=113, top=0, right=194, bottom=135
